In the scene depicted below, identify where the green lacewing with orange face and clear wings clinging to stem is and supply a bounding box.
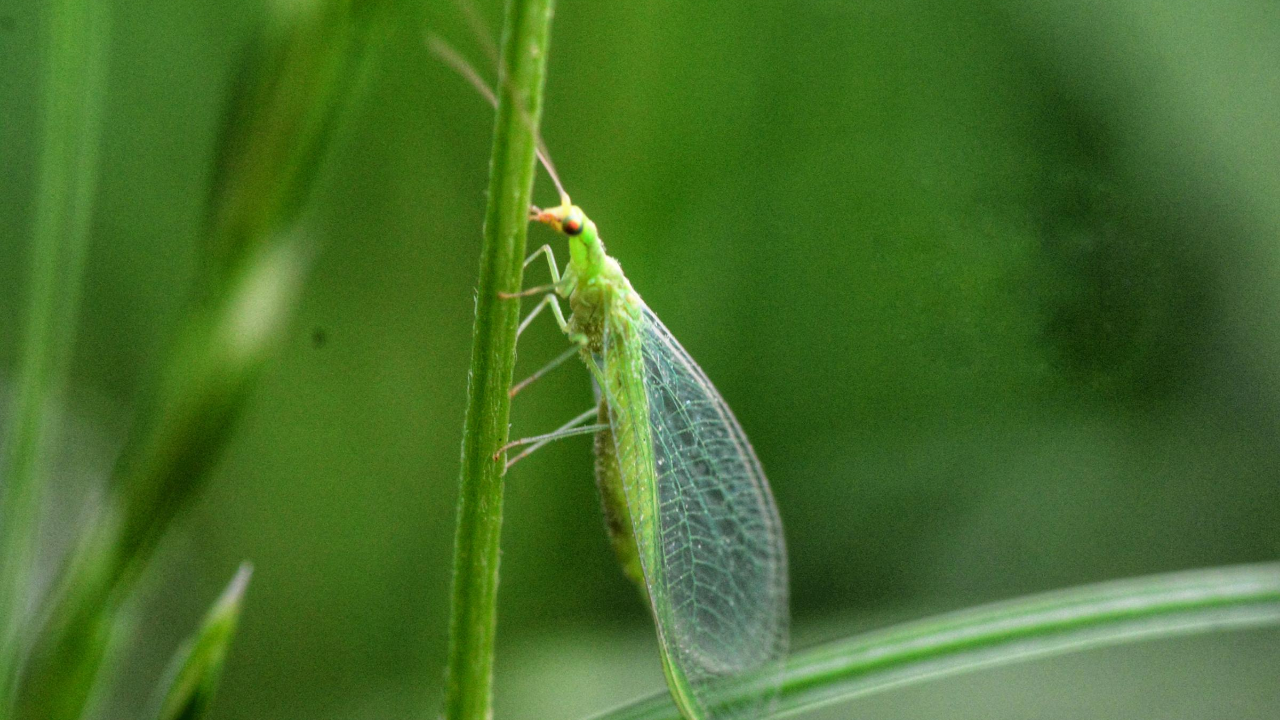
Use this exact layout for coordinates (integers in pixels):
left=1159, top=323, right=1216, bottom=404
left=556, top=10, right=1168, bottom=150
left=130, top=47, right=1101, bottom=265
left=436, top=32, right=790, bottom=720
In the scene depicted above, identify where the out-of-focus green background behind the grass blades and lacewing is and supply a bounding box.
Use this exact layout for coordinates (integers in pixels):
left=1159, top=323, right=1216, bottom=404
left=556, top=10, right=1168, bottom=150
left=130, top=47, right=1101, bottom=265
left=0, top=0, right=1280, bottom=720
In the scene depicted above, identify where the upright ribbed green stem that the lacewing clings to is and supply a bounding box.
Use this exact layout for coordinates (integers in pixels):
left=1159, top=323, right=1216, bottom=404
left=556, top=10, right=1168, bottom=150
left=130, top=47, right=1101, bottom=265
left=444, top=0, right=553, bottom=720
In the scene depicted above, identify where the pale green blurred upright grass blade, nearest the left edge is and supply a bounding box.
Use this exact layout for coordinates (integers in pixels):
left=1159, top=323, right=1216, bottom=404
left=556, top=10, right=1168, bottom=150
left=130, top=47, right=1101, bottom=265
left=0, top=0, right=110, bottom=717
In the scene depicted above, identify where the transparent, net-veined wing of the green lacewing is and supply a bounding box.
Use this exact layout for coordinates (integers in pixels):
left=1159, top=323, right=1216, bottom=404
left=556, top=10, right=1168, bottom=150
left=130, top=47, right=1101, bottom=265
left=604, top=307, right=790, bottom=719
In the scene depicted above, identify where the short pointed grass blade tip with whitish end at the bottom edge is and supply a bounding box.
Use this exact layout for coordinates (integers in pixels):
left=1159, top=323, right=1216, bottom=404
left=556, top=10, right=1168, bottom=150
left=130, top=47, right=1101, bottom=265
left=152, top=562, right=253, bottom=720
